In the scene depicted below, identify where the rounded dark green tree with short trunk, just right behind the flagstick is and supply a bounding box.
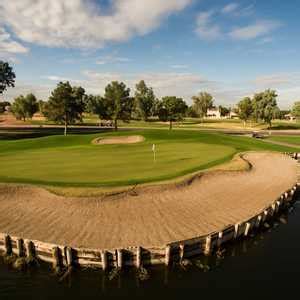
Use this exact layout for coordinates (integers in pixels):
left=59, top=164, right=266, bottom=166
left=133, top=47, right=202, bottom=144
left=159, top=96, right=187, bottom=130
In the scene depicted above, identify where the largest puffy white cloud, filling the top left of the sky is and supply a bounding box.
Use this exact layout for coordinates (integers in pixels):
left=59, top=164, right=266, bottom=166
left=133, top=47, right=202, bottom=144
left=0, top=0, right=191, bottom=48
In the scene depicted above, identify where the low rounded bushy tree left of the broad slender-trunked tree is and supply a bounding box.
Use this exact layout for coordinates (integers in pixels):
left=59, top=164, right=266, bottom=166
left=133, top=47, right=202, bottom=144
left=11, top=94, right=38, bottom=122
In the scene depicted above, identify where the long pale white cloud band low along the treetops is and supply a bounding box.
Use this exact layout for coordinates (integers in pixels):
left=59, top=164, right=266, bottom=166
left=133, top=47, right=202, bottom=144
left=1, top=70, right=300, bottom=109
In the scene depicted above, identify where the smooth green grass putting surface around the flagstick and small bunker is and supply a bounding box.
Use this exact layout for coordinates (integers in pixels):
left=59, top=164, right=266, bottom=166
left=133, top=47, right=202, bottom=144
left=0, top=130, right=297, bottom=187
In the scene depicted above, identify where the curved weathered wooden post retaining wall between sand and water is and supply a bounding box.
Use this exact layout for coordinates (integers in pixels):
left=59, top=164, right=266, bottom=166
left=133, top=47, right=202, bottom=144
left=0, top=153, right=300, bottom=270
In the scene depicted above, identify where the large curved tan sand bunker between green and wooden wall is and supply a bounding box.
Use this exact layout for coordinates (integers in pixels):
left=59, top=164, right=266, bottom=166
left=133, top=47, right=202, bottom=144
left=0, top=153, right=297, bottom=249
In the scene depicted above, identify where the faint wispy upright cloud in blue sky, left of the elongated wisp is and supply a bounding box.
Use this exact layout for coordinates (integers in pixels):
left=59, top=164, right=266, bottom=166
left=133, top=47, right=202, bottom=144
left=195, top=10, right=222, bottom=41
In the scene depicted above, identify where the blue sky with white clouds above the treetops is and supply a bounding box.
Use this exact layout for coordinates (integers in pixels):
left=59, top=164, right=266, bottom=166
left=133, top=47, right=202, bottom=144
left=0, top=0, right=300, bottom=109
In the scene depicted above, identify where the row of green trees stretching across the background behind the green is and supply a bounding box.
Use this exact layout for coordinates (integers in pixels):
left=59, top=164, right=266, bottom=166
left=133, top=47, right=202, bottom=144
left=0, top=61, right=300, bottom=134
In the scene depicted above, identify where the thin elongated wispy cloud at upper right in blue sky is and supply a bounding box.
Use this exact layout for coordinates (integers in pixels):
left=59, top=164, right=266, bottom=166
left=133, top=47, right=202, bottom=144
left=229, top=20, right=282, bottom=40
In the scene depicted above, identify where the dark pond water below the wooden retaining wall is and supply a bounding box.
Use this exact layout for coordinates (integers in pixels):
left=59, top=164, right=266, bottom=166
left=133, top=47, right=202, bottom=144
left=0, top=193, right=300, bottom=299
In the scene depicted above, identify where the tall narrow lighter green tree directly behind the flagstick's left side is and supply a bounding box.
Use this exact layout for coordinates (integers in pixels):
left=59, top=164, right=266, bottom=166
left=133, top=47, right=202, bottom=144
left=135, top=80, right=155, bottom=121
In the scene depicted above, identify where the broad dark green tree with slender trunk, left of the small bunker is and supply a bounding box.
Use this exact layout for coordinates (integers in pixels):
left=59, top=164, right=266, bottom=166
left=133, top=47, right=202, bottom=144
left=44, top=81, right=82, bottom=135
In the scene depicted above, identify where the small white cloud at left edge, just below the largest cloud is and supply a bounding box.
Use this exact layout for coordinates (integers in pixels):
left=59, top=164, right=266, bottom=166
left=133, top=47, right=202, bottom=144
left=0, top=27, right=29, bottom=62
